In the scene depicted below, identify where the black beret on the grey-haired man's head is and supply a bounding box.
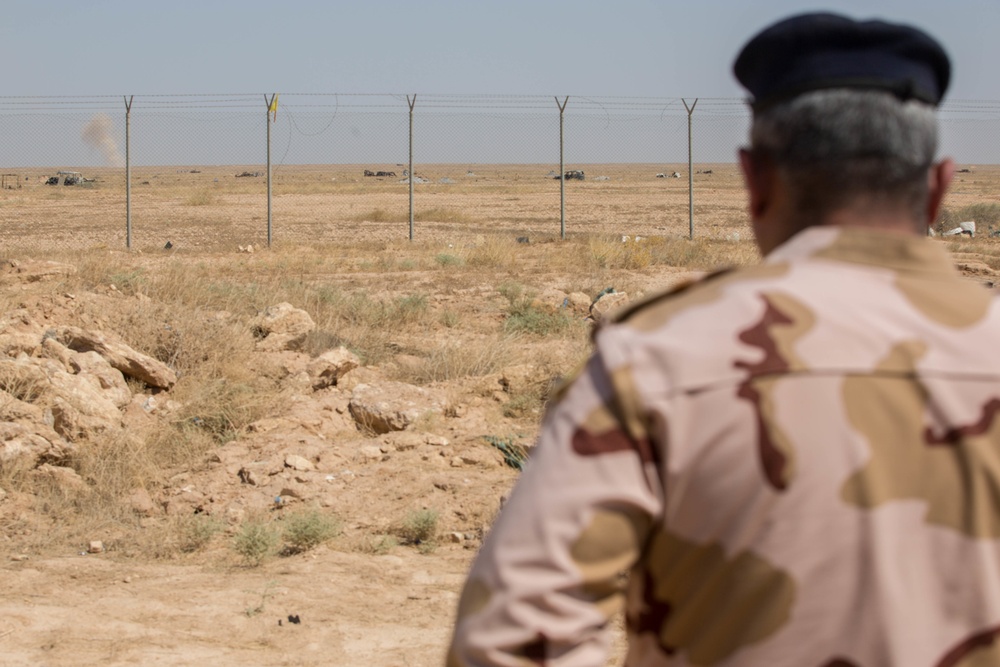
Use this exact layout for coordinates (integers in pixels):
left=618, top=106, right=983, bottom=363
left=733, top=13, right=951, bottom=111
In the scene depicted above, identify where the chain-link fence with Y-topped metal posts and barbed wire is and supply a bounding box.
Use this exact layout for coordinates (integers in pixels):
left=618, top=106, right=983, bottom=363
left=0, top=94, right=1000, bottom=249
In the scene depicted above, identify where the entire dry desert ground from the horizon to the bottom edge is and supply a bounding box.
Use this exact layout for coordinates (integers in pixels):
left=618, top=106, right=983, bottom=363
left=0, top=159, right=1000, bottom=667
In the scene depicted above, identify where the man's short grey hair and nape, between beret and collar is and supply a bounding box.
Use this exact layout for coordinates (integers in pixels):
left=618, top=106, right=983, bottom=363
left=750, top=89, right=937, bottom=225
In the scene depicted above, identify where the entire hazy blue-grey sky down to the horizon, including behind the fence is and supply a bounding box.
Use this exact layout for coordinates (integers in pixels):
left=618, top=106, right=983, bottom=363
left=0, top=0, right=1000, bottom=166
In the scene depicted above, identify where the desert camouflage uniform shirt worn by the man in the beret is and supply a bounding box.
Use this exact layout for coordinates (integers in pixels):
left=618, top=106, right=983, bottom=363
left=448, top=227, right=1000, bottom=667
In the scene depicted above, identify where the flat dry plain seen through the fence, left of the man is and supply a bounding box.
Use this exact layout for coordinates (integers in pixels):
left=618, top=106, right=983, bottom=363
left=0, top=165, right=746, bottom=250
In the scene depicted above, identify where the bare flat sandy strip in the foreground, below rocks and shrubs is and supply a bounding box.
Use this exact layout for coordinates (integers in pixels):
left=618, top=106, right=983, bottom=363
left=0, top=545, right=470, bottom=667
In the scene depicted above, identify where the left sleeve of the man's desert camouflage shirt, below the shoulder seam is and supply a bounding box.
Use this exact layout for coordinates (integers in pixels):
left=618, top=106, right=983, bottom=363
left=447, top=352, right=662, bottom=667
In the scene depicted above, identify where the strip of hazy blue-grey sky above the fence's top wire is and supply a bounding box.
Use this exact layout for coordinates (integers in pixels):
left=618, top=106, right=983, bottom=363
left=0, top=0, right=1000, bottom=100
